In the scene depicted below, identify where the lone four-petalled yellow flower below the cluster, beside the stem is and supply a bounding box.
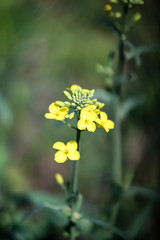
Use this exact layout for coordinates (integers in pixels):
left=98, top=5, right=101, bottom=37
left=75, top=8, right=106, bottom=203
left=53, top=141, right=80, bottom=163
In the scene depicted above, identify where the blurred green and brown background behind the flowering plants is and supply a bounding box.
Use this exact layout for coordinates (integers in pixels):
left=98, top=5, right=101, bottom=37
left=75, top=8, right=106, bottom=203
left=0, top=0, right=160, bottom=240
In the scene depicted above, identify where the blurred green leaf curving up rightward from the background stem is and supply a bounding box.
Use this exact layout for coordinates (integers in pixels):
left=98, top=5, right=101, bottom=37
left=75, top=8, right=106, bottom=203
left=118, top=97, right=142, bottom=120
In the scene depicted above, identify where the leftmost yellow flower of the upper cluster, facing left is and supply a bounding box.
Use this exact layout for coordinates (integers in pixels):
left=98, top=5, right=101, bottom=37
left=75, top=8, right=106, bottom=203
left=45, top=103, right=69, bottom=121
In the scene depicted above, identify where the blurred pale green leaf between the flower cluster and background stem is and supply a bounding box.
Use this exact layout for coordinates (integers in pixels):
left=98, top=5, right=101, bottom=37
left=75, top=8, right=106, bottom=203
left=94, top=89, right=117, bottom=104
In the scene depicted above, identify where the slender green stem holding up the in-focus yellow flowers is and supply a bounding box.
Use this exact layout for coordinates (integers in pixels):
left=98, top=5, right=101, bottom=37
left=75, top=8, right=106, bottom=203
left=70, top=118, right=81, bottom=240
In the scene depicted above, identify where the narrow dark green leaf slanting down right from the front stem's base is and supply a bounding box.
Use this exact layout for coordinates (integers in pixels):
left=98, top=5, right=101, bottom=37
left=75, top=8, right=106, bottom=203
left=84, top=217, right=133, bottom=240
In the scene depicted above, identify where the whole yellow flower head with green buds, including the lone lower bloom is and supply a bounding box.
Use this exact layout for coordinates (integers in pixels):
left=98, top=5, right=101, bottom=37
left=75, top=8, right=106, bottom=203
left=45, top=85, right=114, bottom=163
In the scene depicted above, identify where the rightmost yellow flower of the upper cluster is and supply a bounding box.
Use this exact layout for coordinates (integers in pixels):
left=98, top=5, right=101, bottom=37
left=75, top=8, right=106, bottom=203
left=96, top=112, right=114, bottom=132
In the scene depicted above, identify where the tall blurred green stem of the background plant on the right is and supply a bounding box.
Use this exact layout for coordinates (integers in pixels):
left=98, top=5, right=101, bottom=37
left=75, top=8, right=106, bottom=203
left=113, top=4, right=128, bottom=185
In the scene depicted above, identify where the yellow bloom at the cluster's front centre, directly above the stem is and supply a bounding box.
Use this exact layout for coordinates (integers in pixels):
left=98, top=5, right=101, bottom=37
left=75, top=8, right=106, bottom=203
left=77, top=105, right=99, bottom=132
